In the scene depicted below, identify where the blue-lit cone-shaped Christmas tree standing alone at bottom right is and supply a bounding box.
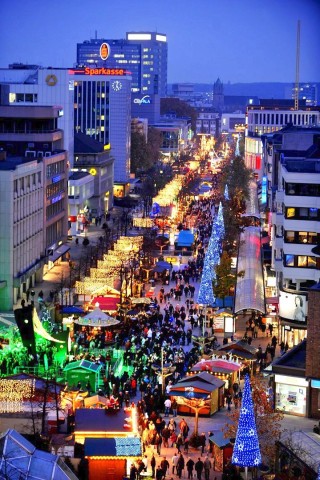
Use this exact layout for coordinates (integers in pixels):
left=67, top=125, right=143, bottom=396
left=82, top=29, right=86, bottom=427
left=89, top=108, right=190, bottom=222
left=231, top=375, right=261, bottom=467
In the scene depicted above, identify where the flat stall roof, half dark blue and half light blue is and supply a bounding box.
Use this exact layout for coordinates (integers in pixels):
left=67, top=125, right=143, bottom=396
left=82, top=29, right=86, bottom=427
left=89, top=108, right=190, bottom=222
left=84, top=437, right=142, bottom=457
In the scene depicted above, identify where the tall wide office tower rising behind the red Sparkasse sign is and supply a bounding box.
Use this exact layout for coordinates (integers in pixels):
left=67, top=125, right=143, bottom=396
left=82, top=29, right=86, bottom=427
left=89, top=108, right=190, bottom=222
left=77, top=32, right=168, bottom=97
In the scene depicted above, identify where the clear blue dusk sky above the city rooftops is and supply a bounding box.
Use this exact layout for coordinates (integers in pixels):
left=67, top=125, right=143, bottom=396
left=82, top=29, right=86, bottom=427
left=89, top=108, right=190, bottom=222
left=0, top=0, right=320, bottom=83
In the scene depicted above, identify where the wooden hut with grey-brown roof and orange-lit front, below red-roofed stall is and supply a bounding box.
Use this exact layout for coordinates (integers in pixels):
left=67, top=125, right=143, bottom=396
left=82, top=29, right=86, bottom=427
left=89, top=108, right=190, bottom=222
left=170, top=372, right=225, bottom=416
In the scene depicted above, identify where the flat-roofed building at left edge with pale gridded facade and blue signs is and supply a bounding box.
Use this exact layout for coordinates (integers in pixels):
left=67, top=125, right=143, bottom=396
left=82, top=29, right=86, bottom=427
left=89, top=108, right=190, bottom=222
left=0, top=106, right=69, bottom=311
